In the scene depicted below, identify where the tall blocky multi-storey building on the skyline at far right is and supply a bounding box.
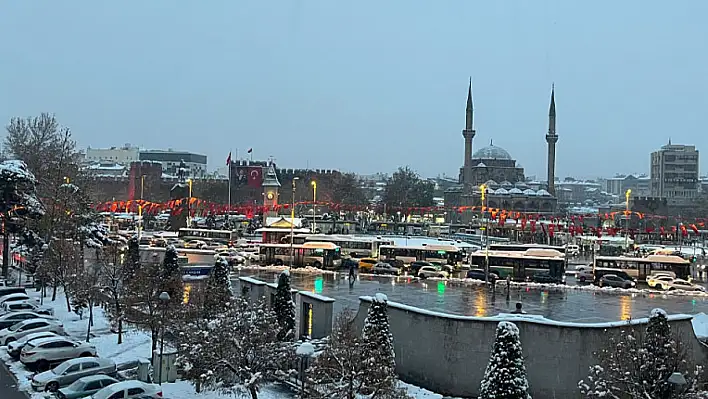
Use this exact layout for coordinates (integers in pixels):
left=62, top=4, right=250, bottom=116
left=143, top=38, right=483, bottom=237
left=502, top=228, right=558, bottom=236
left=651, top=140, right=700, bottom=205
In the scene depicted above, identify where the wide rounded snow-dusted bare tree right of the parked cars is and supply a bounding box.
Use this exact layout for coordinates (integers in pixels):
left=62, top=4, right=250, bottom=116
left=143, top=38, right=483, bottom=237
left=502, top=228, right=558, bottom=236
left=178, top=297, right=289, bottom=399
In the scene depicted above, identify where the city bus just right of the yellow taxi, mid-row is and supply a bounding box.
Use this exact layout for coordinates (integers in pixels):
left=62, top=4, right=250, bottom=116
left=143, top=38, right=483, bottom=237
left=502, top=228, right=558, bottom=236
left=379, top=244, right=463, bottom=266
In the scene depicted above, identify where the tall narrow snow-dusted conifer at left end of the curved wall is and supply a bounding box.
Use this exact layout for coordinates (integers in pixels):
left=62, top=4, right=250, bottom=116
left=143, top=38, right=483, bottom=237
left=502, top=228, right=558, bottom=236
left=361, top=293, right=396, bottom=391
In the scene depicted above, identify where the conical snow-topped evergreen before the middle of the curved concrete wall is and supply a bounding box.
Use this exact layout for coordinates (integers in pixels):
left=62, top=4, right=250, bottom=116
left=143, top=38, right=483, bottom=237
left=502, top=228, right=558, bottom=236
left=479, top=321, right=531, bottom=399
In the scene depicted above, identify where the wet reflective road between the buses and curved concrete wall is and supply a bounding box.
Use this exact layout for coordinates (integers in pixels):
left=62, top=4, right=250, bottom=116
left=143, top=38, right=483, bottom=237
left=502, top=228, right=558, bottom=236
left=234, top=270, right=708, bottom=323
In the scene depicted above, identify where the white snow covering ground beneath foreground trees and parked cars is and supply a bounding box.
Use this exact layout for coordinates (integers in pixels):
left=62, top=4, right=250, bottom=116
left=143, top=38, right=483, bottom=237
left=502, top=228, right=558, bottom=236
left=0, top=290, right=442, bottom=399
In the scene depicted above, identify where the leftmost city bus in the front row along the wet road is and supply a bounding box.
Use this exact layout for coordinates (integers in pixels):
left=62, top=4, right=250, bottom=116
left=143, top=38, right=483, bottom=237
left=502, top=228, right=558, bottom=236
left=258, top=241, right=342, bottom=269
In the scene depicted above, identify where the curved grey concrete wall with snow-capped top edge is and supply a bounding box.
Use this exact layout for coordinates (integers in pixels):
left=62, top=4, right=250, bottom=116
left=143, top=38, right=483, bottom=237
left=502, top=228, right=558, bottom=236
left=355, top=297, right=708, bottom=399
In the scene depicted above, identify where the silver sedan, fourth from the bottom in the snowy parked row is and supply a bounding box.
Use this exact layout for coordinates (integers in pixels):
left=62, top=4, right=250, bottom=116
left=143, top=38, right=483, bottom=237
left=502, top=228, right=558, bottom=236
left=20, top=336, right=96, bottom=371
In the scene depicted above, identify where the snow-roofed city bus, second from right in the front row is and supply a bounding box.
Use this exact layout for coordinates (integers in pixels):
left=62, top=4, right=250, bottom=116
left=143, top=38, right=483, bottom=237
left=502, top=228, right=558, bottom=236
left=470, top=248, right=565, bottom=283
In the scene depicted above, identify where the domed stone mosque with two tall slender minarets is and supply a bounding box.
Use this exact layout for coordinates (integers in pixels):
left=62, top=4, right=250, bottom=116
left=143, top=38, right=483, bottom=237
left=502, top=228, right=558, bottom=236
left=444, top=83, right=558, bottom=219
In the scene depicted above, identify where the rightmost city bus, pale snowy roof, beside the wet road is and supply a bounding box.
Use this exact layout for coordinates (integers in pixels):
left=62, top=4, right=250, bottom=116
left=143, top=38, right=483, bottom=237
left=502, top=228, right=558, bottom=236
left=593, top=255, right=691, bottom=281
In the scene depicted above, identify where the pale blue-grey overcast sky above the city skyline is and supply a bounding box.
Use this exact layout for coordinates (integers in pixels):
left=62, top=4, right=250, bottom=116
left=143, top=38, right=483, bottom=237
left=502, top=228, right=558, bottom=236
left=0, top=0, right=708, bottom=177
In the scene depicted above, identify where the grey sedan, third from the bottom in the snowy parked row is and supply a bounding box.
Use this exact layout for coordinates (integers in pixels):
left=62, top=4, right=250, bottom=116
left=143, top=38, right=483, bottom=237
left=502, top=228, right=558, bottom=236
left=32, top=357, right=118, bottom=392
